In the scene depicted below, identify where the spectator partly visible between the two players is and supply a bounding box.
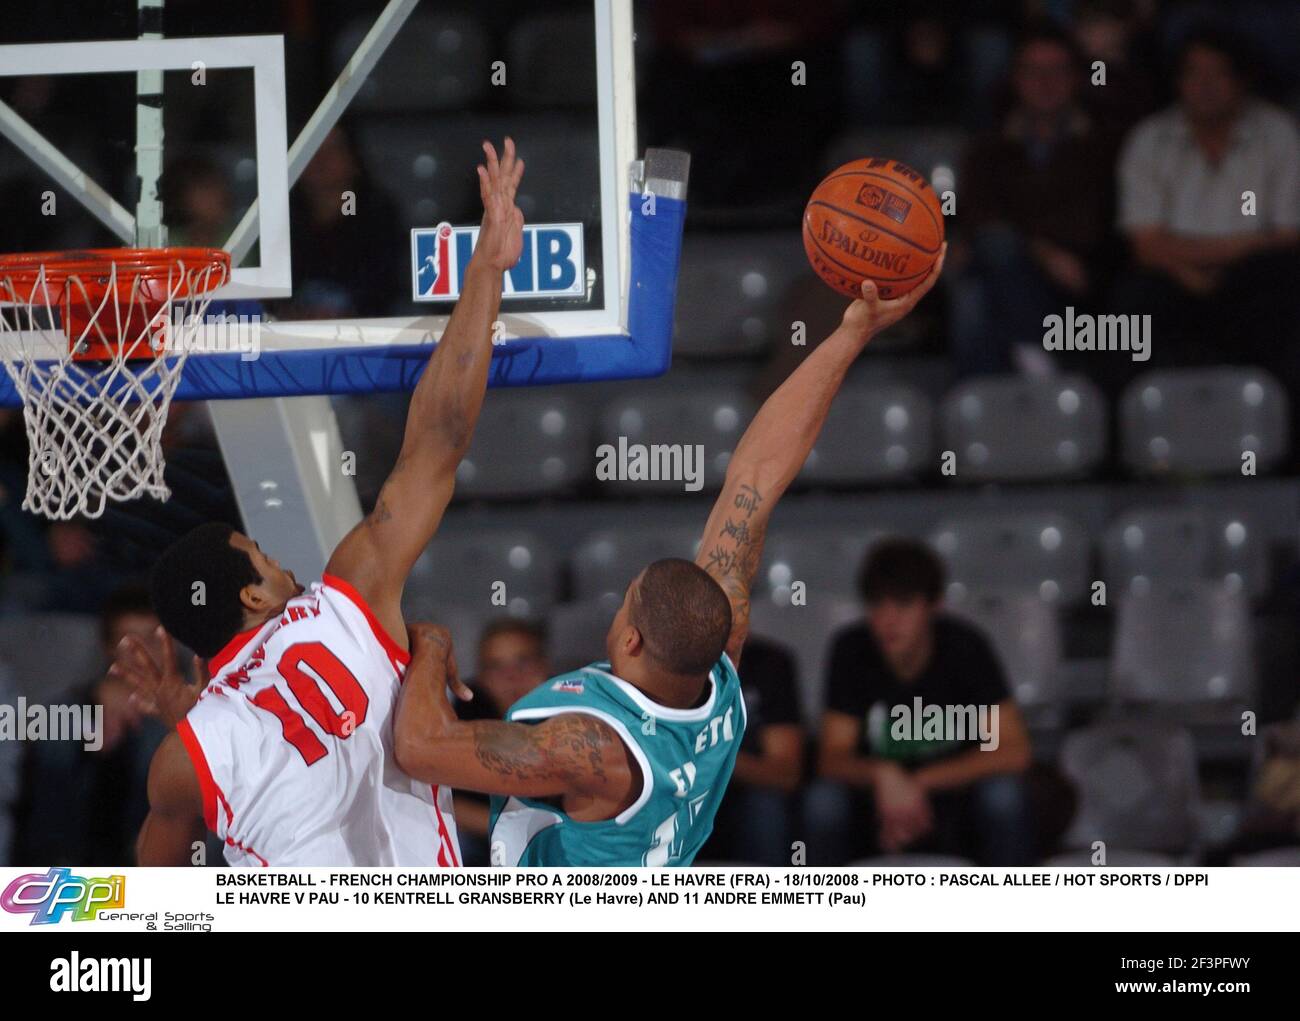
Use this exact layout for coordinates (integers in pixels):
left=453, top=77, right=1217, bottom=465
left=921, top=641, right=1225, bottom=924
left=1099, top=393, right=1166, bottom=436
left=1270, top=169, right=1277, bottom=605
left=455, top=618, right=551, bottom=865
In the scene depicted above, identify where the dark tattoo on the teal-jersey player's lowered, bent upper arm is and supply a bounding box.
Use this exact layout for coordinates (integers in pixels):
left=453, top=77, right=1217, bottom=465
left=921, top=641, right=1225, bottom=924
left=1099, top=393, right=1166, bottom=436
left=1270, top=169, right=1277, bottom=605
left=475, top=713, right=610, bottom=793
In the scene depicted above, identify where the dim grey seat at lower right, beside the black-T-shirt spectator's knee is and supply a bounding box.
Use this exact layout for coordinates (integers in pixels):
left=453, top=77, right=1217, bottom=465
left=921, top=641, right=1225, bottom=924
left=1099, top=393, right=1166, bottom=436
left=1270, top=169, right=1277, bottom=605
left=1061, top=719, right=1200, bottom=861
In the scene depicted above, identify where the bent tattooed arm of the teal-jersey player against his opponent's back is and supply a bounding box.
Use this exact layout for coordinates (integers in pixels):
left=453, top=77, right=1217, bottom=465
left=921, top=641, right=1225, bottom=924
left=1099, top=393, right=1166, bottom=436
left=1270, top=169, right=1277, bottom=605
left=394, top=624, right=641, bottom=819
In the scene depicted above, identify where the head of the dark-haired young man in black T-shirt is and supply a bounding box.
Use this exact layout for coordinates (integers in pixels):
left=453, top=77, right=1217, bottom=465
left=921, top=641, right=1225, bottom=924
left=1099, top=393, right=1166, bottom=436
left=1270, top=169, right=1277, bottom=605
left=858, top=538, right=944, bottom=659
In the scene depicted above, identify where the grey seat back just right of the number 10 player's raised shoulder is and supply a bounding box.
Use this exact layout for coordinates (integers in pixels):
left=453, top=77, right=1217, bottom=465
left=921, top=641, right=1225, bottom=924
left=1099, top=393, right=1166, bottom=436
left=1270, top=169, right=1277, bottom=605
left=407, top=529, right=556, bottom=617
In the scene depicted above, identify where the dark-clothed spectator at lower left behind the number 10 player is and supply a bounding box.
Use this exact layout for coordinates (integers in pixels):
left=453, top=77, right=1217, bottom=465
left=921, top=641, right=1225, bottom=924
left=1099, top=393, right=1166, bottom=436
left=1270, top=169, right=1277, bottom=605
left=14, top=587, right=165, bottom=866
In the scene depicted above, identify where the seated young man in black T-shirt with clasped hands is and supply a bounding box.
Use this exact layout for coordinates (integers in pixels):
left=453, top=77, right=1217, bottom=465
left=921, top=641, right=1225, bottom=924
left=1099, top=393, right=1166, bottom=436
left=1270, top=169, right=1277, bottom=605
left=806, top=538, right=1035, bottom=865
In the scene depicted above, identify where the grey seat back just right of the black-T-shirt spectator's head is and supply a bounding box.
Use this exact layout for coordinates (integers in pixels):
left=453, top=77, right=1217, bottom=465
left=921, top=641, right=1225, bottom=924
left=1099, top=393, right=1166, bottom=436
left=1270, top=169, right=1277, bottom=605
left=931, top=511, right=1091, bottom=605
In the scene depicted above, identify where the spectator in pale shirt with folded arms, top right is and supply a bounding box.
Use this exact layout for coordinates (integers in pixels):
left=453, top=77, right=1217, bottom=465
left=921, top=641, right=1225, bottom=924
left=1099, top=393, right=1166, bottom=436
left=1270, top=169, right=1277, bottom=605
left=1113, top=30, right=1300, bottom=385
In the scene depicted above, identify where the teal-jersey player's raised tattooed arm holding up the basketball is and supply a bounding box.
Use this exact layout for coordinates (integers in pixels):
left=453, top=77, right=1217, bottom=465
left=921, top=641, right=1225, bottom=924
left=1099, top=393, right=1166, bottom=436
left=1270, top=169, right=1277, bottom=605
left=696, top=251, right=948, bottom=663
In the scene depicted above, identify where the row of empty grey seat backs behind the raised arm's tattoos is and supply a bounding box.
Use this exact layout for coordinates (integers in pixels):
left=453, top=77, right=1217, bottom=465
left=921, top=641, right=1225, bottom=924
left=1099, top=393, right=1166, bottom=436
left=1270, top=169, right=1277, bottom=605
left=408, top=496, right=1270, bottom=624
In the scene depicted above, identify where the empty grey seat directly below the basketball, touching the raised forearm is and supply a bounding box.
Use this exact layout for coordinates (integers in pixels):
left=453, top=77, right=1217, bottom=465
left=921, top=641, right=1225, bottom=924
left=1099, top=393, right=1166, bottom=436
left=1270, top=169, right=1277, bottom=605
left=800, top=384, right=933, bottom=484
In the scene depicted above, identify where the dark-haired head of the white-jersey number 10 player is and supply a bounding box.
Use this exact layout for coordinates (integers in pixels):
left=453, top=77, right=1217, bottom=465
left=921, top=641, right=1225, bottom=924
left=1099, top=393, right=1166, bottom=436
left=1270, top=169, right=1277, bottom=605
left=150, top=522, right=303, bottom=657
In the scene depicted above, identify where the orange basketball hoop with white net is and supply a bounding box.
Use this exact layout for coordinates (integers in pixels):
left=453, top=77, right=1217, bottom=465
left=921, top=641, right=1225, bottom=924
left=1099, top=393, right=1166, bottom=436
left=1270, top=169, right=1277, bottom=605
left=0, top=248, right=230, bottom=520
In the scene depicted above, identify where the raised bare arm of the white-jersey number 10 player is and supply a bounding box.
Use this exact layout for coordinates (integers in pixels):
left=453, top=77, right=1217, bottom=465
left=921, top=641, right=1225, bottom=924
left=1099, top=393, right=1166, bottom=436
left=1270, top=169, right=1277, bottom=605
left=325, top=138, right=524, bottom=644
